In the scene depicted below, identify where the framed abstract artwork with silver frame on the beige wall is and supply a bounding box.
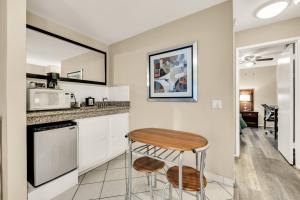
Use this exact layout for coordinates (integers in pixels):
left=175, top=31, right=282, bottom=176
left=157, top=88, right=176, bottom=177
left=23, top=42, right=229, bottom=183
left=148, top=42, right=198, bottom=102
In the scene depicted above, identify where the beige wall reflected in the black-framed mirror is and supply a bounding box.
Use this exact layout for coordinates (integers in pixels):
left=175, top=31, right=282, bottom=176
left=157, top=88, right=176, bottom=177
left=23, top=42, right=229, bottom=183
left=61, top=51, right=105, bottom=82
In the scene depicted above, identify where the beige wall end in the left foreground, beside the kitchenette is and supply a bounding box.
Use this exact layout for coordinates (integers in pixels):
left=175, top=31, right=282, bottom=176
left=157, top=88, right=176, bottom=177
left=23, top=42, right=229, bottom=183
left=0, top=0, right=27, bottom=200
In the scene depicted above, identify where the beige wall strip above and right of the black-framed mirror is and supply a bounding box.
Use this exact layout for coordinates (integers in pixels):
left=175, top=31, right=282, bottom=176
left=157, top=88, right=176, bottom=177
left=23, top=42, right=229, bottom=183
left=27, top=12, right=111, bottom=83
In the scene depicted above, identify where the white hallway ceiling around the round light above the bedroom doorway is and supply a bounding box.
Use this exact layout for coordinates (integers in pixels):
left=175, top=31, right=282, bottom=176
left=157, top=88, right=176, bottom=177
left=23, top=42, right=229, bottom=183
left=235, top=0, right=300, bottom=31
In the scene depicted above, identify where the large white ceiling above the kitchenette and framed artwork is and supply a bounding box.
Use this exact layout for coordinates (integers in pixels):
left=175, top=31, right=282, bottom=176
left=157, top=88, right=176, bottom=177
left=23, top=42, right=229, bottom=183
left=27, top=0, right=226, bottom=44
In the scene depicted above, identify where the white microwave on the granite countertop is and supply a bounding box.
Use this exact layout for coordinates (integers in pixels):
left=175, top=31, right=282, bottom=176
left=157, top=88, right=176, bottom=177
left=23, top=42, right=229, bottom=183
left=27, top=88, right=71, bottom=111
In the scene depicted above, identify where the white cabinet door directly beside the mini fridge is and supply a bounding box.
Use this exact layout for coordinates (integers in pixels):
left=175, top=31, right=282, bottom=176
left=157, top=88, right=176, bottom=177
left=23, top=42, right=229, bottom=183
left=77, top=116, right=108, bottom=172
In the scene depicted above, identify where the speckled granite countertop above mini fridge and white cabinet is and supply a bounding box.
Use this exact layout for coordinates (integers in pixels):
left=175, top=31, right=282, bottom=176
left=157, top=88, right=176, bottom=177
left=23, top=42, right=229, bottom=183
left=27, top=101, right=130, bottom=125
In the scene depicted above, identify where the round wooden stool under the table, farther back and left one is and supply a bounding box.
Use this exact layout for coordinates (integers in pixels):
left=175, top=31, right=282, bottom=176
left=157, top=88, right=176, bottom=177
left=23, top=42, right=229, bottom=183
left=133, top=156, right=165, bottom=200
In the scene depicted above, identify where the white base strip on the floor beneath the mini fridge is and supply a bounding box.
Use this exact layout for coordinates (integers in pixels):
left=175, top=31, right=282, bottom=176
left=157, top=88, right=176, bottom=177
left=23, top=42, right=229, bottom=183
left=28, top=170, right=78, bottom=200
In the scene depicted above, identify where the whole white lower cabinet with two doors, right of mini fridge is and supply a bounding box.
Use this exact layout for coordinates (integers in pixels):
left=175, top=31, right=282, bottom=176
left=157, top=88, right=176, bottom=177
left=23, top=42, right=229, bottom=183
left=76, top=113, right=129, bottom=173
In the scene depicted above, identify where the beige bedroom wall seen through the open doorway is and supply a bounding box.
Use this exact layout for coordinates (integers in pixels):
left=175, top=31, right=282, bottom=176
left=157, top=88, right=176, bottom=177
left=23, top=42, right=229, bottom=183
left=240, top=66, right=277, bottom=126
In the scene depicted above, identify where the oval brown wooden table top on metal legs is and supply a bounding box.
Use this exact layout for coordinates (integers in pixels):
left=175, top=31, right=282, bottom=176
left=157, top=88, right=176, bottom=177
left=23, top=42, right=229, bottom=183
left=128, top=128, right=208, bottom=151
